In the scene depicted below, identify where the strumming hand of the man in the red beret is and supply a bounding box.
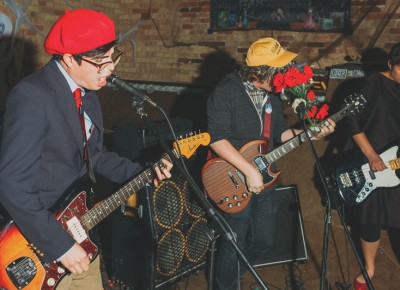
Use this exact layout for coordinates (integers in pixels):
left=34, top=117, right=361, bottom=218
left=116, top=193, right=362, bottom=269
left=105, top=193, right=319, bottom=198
left=60, top=243, right=90, bottom=274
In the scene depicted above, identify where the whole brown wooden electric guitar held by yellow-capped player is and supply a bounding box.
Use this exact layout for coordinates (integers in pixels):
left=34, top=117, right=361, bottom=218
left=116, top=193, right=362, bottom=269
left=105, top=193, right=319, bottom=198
left=202, top=95, right=366, bottom=213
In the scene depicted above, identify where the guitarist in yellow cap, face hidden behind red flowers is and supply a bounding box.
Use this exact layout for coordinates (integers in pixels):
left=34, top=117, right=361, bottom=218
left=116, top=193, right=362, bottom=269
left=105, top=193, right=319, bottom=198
left=207, top=38, right=335, bottom=290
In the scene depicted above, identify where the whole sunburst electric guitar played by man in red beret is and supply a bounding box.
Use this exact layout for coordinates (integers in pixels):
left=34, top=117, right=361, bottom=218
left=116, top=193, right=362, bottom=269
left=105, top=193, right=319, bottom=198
left=0, top=133, right=210, bottom=290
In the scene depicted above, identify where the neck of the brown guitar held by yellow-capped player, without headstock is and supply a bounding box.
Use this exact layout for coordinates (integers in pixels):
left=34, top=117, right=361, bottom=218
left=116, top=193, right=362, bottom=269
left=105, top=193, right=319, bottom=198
left=265, top=110, right=343, bottom=164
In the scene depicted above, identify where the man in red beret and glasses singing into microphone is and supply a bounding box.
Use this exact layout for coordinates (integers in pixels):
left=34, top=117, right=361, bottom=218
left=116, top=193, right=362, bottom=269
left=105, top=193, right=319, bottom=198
left=0, top=9, right=172, bottom=290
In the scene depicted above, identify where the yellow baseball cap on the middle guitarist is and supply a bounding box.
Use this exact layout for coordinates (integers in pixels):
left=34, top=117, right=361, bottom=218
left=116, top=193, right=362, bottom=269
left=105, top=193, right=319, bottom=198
left=246, top=37, right=298, bottom=67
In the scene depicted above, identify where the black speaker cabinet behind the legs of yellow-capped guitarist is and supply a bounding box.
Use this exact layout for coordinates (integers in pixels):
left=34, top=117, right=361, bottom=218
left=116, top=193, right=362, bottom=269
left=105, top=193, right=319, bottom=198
left=253, top=185, right=308, bottom=267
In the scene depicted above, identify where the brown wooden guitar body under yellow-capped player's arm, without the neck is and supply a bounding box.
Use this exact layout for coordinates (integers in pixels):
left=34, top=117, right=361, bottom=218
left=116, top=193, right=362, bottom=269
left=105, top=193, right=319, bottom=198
left=202, top=140, right=280, bottom=213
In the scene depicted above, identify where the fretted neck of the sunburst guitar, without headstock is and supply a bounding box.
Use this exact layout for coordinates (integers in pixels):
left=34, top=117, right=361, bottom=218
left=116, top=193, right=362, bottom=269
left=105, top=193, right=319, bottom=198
left=81, top=150, right=176, bottom=230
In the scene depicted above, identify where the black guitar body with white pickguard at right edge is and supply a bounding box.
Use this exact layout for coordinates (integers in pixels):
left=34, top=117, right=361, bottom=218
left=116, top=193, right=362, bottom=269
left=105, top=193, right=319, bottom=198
left=336, top=140, right=400, bottom=205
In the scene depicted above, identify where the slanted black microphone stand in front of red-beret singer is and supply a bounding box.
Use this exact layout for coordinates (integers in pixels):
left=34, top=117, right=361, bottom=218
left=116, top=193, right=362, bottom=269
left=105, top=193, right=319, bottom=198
left=132, top=96, right=268, bottom=290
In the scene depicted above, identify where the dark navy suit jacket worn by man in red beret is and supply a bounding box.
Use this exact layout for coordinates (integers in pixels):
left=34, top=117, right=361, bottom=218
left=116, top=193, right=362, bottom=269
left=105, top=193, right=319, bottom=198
left=0, top=61, right=141, bottom=261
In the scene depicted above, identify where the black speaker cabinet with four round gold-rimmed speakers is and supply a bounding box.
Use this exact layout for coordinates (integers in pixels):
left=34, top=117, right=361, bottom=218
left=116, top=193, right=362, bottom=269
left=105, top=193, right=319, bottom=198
left=111, top=172, right=209, bottom=290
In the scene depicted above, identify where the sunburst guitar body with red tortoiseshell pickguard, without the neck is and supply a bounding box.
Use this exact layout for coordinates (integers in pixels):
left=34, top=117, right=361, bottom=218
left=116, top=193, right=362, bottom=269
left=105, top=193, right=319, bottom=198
left=0, top=177, right=98, bottom=290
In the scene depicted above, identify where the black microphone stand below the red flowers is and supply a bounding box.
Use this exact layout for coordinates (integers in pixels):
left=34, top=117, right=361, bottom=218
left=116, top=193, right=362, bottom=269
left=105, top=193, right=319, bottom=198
left=295, top=102, right=374, bottom=290
